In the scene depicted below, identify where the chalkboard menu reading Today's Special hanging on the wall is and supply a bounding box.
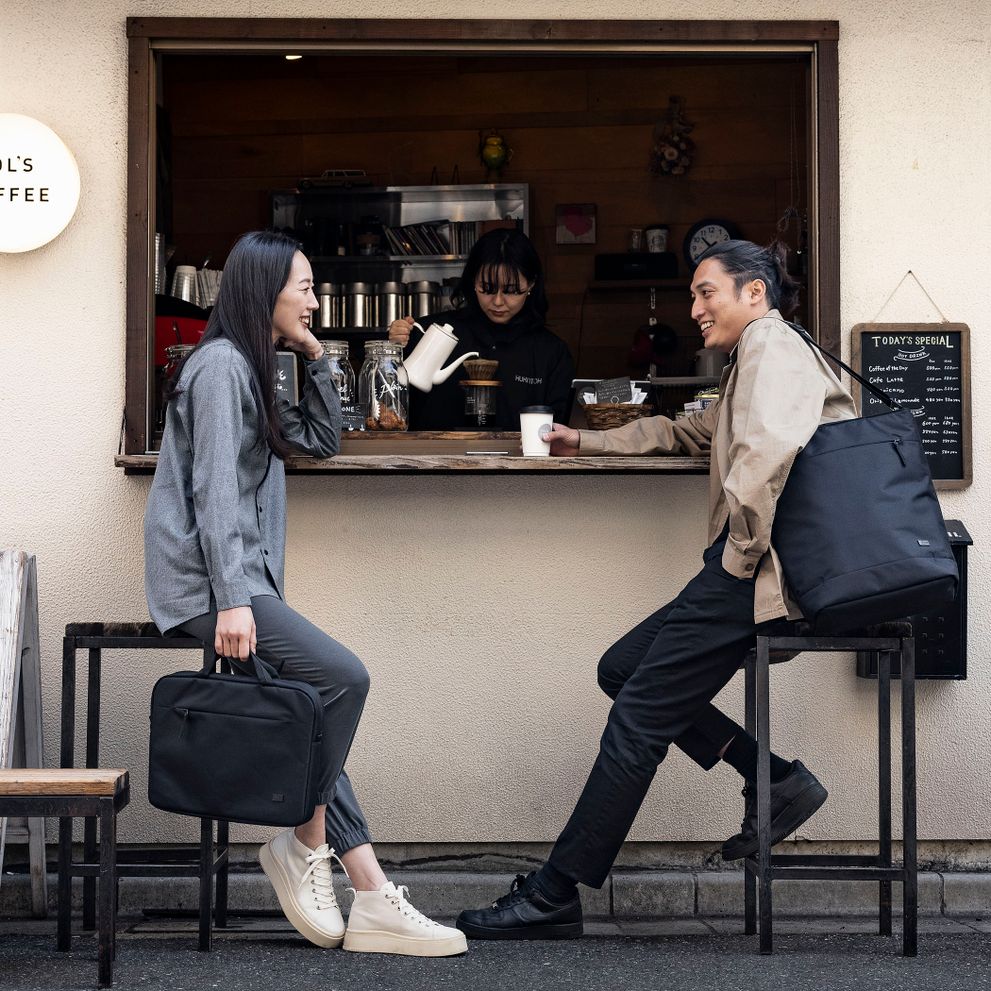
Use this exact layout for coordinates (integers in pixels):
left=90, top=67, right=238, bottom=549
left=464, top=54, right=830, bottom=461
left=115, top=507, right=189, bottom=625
left=851, top=323, right=973, bottom=489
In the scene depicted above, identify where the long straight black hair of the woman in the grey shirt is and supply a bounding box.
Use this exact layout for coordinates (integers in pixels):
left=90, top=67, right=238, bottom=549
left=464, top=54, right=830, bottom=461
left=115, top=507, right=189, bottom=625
left=166, top=231, right=301, bottom=459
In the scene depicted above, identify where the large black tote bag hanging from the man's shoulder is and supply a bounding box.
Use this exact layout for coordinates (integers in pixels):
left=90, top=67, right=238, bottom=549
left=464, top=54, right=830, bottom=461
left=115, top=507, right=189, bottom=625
left=771, top=324, right=959, bottom=633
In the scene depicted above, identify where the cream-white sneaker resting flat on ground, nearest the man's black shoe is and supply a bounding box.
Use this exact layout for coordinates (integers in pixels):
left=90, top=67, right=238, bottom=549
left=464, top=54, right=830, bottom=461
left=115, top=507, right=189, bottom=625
left=344, top=881, right=468, bottom=957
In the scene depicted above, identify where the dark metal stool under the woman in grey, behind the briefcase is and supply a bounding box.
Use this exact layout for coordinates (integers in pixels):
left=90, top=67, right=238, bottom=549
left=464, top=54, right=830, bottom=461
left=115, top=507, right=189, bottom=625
left=59, top=623, right=229, bottom=950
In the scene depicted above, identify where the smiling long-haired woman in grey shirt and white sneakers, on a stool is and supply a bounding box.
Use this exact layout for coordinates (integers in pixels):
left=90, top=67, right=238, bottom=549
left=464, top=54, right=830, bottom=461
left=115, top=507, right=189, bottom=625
left=145, top=232, right=466, bottom=956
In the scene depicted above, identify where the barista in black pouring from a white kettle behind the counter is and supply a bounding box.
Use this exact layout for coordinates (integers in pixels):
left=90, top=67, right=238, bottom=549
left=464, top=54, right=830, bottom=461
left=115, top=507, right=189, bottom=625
left=389, top=230, right=575, bottom=430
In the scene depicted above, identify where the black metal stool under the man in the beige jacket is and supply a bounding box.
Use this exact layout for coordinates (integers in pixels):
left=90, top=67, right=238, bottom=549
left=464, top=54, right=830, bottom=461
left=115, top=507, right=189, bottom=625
left=744, top=621, right=918, bottom=957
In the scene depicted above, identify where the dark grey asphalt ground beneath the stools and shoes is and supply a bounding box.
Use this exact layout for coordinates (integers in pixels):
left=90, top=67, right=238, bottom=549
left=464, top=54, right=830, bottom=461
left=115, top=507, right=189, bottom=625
left=0, top=916, right=991, bottom=991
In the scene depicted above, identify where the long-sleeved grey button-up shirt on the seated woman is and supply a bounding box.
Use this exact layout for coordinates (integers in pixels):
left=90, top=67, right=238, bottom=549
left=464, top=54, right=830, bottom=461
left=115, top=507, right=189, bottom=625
left=145, top=339, right=341, bottom=632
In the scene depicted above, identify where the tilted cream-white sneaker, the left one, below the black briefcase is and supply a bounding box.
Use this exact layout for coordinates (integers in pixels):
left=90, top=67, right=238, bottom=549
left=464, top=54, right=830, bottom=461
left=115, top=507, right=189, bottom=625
left=258, top=829, right=344, bottom=947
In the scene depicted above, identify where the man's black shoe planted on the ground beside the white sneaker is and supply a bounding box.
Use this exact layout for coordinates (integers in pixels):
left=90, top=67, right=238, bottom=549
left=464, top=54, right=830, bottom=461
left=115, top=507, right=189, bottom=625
left=455, top=871, right=582, bottom=939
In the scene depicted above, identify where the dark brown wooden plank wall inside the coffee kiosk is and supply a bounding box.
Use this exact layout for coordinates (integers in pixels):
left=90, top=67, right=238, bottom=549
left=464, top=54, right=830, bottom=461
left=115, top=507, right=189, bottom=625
left=163, top=54, right=808, bottom=376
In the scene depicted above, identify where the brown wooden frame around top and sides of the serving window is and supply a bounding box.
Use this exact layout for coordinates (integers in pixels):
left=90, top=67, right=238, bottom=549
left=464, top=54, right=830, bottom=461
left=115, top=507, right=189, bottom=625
left=124, top=17, right=840, bottom=455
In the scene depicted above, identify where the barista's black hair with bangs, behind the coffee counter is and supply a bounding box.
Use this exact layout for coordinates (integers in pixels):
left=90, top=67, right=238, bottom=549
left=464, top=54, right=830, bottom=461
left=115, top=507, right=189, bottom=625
left=453, top=228, right=547, bottom=327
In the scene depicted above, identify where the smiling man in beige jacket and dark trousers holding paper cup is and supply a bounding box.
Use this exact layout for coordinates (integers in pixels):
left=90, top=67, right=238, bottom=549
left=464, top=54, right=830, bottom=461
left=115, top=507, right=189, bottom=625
left=457, top=241, right=857, bottom=939
